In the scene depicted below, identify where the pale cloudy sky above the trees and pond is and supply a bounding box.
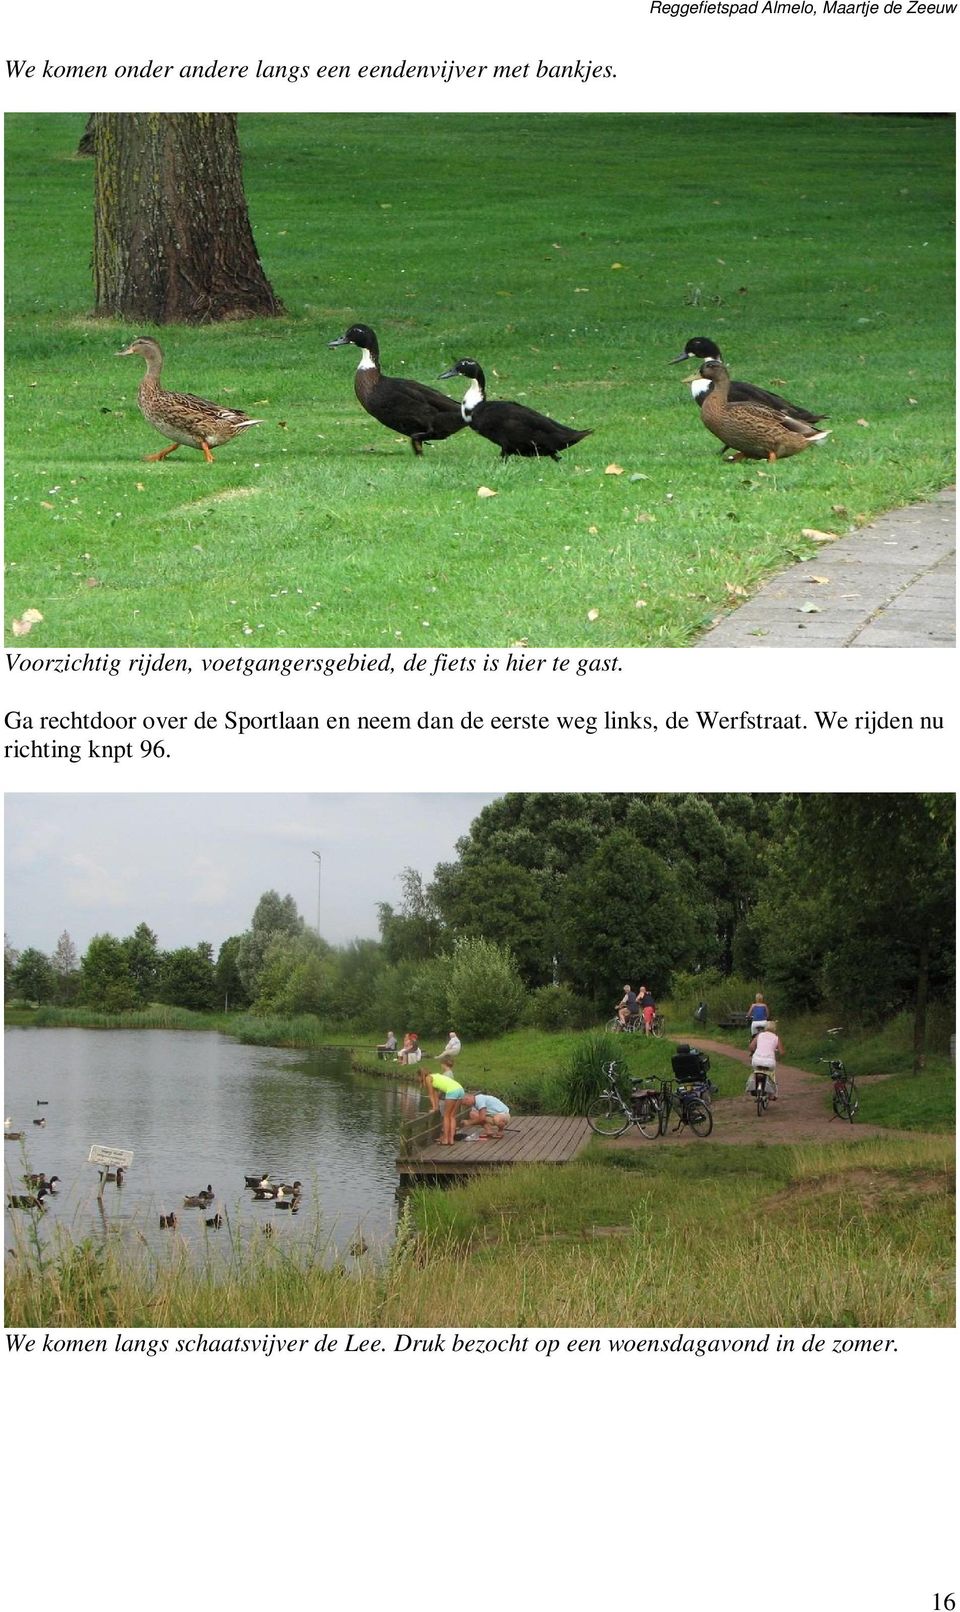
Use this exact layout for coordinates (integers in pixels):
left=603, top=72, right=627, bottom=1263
left=5, top=795, right=494, bottom=953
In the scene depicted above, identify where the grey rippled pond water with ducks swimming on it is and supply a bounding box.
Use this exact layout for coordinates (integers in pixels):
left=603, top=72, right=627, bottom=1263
left=3, top=1028, right=424, bottom=1262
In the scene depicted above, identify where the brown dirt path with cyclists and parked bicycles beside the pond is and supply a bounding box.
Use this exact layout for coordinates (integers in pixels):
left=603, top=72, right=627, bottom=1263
left=602, top=1035, right=921, bottom=1148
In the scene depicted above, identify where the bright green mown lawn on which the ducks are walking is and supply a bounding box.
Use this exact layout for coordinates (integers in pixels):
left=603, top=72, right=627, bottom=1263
left=6, top=114, right=954, bottom=650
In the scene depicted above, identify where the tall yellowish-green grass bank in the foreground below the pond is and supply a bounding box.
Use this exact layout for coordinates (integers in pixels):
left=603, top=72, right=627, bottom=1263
left=6, top=1138, right=954, bottom=1327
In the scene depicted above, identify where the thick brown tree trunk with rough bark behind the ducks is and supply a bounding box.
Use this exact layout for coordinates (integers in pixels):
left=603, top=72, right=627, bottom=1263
left=93, top=113, right=283, bottom=326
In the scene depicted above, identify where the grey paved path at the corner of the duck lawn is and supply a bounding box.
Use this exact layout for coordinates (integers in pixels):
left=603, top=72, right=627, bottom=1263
left=694, top=487, right=957, bottom=650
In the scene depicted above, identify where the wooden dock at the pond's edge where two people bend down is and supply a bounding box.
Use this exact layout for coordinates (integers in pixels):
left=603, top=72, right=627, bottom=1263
left=396, top=1114, right=591, bottom=1178
